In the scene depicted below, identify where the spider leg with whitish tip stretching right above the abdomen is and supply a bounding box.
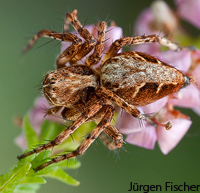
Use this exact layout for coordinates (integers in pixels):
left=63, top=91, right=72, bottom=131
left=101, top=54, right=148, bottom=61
left=101, top=34, right=180, bottom=65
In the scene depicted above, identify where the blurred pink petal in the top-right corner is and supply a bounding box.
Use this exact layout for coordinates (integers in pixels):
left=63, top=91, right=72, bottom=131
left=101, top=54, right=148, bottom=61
left=175, top=0, right=200, bottom=28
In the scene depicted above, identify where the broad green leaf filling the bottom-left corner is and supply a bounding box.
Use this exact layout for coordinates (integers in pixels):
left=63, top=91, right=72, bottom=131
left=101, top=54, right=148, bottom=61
left=0, top=162, right=31, bottom=193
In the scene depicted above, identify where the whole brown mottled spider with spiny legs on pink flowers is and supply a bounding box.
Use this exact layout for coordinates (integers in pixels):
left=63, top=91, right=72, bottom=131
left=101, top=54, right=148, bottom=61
left=18, top=11, right=194, bottom=171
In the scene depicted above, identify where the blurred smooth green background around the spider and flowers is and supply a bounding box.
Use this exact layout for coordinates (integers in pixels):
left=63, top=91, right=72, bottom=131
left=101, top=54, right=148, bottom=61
left=0, top=0, right=200, bottom=193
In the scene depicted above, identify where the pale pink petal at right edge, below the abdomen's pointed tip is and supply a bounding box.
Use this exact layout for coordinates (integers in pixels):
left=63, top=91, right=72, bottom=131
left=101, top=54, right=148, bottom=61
left=169, top=84, right=200, bottom=108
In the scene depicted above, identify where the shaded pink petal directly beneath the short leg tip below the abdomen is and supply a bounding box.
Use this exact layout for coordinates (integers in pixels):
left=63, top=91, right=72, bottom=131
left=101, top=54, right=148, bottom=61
left=116, top=109, right=146, bottom=134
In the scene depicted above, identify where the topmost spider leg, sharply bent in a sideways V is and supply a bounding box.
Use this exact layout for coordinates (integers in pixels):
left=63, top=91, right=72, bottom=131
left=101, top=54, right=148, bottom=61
left=66, top=13, right=96, bottom=63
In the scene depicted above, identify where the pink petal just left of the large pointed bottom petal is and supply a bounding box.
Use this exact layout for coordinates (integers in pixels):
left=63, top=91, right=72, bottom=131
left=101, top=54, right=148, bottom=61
left=125, top=125, right=157, bottom=149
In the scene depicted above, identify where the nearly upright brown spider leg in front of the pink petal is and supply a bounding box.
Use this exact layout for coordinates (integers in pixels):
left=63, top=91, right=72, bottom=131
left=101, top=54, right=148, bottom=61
left=85, top=21, right=107, bottom=66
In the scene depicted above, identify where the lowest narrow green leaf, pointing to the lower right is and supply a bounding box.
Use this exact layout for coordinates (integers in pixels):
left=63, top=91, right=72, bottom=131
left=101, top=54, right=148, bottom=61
left=44, top=167, right=80, bottom=186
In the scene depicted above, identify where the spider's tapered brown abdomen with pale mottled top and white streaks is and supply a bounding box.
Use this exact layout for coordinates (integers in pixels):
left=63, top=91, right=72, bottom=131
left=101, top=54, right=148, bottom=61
left=100, top=51, right=189, bottom=106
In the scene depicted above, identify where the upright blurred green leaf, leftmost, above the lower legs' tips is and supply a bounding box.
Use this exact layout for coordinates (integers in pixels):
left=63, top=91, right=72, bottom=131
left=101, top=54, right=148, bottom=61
left=22, top=115, right=39, bottom=150
